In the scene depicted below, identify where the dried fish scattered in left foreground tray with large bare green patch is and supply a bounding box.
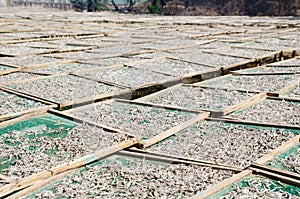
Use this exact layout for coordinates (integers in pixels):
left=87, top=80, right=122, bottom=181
left=0, top=124, right=127, bottom=178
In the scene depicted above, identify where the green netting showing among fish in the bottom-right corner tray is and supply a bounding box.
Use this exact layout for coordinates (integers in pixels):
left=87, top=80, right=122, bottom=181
left=207, top=175, right=300, bottom=199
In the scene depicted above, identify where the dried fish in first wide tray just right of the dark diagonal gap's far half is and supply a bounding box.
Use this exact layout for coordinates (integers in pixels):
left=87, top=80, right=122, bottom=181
left=204, top=75, right=299, bottom=92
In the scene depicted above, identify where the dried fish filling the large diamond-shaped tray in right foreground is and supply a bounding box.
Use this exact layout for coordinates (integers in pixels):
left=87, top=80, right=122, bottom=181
left=147, top=122, right=294, bottom=167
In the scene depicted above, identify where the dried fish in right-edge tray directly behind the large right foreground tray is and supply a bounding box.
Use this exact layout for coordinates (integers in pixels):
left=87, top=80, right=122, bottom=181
left=230, top=100, right=300, bottom=126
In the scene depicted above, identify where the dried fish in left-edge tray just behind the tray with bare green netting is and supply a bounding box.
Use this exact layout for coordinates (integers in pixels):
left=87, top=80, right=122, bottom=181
left=0, top=91, right=45, bottom=115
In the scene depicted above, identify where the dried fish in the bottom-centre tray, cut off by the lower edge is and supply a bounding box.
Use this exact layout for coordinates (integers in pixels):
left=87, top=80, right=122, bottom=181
left=27, top=158, right=233, bottom=198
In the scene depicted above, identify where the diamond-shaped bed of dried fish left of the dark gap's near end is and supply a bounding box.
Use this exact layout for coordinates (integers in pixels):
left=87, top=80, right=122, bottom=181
left=10, top=75, right=120, bottom=103
